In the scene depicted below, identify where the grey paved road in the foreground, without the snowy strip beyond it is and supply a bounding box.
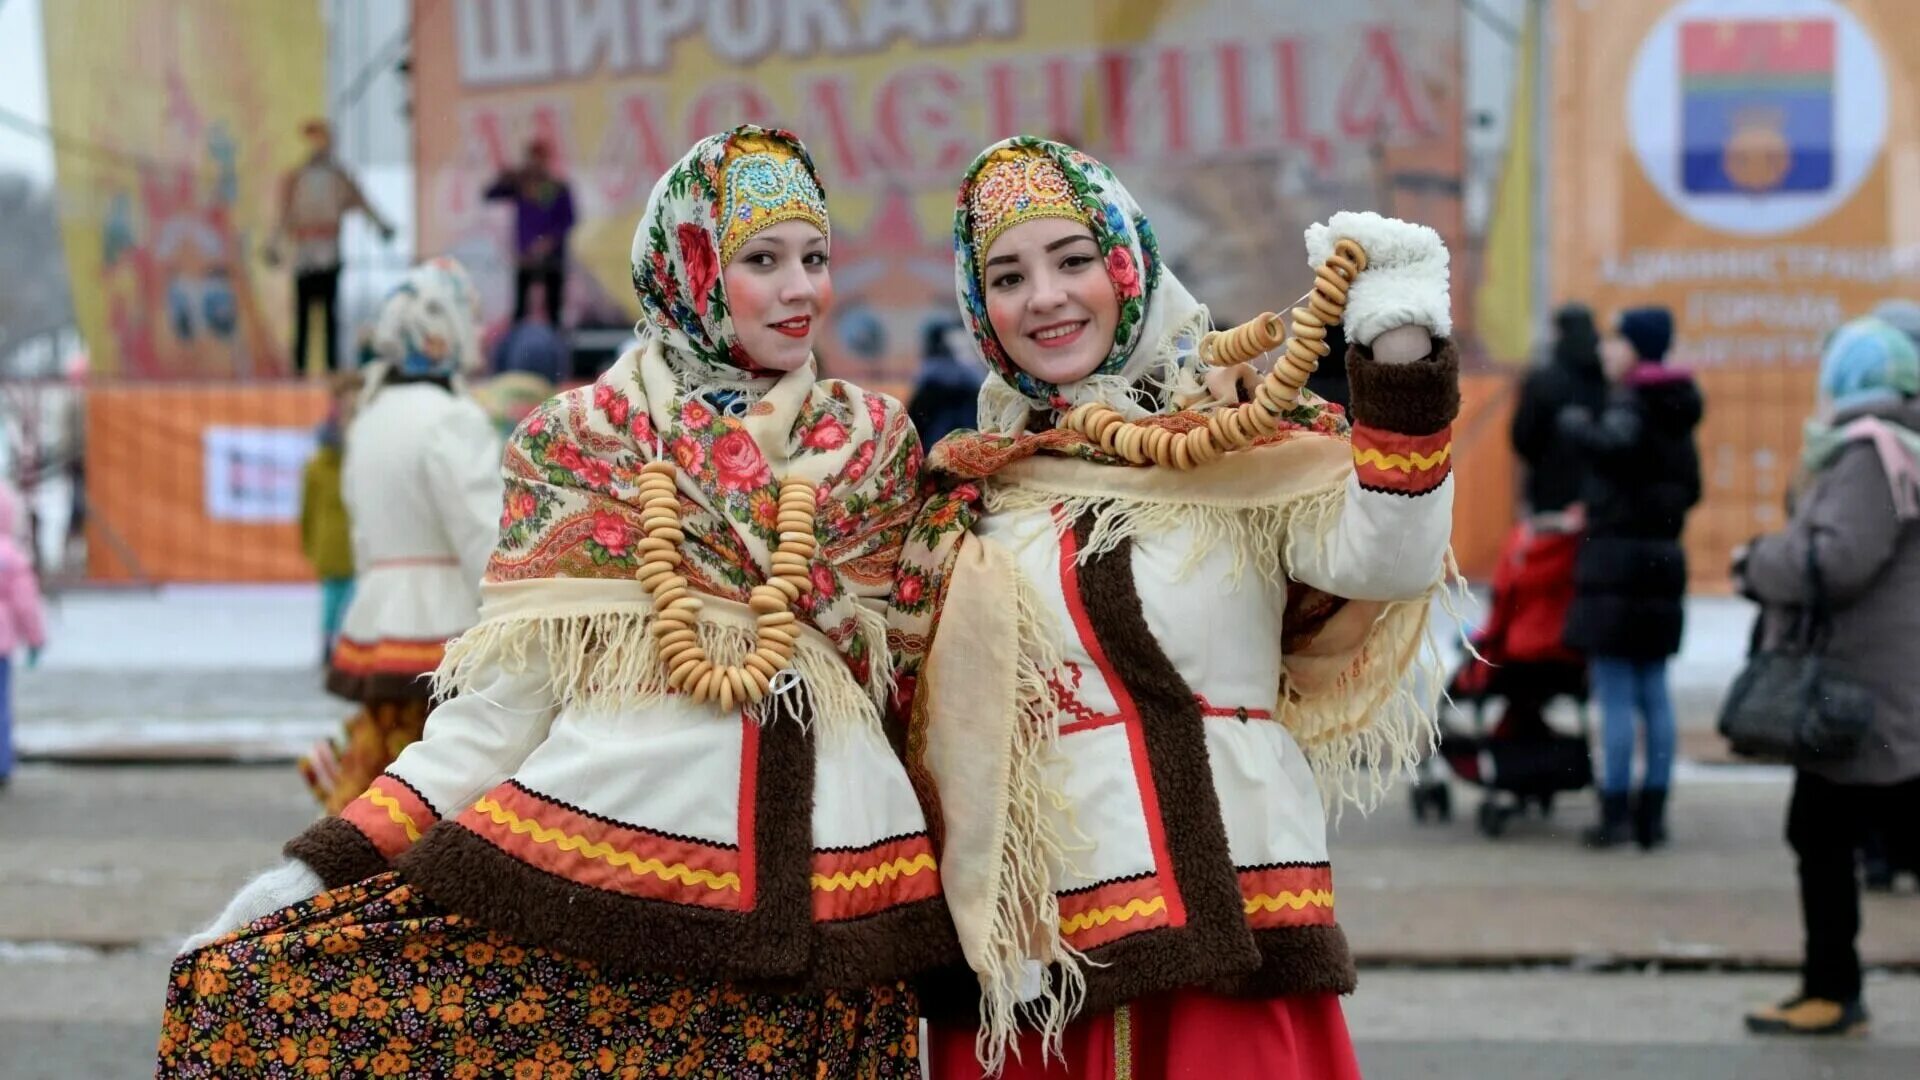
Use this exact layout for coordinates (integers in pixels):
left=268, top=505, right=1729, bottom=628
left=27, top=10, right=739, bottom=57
left=0, top=765, right=1920, bottom=1080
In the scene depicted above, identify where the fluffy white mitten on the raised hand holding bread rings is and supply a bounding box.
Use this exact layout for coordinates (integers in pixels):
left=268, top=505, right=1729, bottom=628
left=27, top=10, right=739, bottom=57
left=1308, top=209, right=1453, bottom=343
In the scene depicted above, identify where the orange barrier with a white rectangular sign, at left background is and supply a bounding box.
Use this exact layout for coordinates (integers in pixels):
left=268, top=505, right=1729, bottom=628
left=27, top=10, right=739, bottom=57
left=86, top=384, right=328, bottom=582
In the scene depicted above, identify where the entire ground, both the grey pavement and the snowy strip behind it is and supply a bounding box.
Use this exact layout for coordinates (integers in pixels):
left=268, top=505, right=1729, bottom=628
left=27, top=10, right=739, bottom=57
left=0, top=588, right=1920, bottom=1080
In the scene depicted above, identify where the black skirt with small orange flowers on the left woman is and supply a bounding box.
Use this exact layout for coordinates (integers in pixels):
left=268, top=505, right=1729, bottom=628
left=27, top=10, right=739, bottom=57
left=157, top=872, right=920, bottom=1080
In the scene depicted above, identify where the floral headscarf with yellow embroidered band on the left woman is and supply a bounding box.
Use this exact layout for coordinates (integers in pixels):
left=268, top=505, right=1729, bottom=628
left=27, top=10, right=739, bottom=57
left=632, top=125, right=828, bottom=390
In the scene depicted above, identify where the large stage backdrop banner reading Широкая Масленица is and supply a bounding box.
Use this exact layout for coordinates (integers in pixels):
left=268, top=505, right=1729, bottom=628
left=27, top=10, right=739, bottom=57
left=413, top=0, right=1473, bottom=386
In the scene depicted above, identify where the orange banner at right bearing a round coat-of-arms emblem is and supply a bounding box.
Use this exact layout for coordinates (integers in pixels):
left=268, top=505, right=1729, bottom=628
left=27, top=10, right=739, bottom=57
left=1549, top=0, right=1920, bottom=584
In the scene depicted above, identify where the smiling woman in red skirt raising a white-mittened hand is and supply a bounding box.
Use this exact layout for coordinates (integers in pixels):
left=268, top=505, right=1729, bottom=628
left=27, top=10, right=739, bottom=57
left=891, top=138, right=1459, bottom=1080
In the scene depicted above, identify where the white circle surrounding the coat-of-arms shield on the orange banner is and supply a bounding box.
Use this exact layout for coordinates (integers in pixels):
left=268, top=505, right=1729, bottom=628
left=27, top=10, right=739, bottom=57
left=1626, top=0, right=1887, bottom=236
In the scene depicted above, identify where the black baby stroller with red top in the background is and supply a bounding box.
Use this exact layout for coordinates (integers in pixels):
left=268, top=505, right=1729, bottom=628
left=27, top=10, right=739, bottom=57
left=1413, top=519, right=1594, bottom=838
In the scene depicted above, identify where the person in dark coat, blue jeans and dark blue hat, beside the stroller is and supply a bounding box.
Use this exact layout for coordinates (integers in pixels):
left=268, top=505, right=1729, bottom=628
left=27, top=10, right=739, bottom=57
left=1557, top=307, right=1703, bottom=847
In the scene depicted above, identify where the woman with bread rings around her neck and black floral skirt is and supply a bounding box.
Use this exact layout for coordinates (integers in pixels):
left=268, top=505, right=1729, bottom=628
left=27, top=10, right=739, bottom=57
left=161, top=127, right=958, bottom=1078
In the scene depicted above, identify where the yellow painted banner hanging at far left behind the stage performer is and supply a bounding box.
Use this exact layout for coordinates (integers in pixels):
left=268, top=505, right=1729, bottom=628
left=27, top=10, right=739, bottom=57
left=42, top=0, right=324, bottom=379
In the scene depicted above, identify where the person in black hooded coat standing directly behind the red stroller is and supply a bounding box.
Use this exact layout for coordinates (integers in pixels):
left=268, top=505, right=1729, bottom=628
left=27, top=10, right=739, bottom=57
left=1513, top=304, right=1607, bottom=513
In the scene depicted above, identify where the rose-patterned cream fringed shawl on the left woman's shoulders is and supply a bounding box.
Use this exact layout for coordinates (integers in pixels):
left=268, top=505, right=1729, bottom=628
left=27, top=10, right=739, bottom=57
left=434, top=338, right=920, bottom=728
